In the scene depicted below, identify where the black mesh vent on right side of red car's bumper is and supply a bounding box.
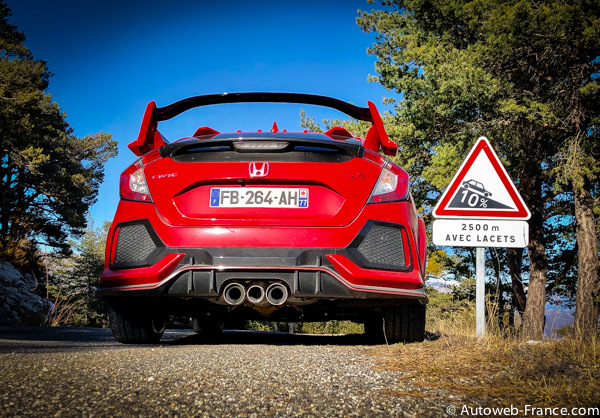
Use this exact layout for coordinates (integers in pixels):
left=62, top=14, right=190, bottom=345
left=358, top=226, right=406, bottom=267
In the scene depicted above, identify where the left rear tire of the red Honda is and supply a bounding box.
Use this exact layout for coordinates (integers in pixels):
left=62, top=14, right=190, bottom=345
left=108, top=307, right=167, bottom=344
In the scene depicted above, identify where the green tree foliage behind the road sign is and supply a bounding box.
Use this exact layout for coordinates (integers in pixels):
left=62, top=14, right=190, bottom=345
left=357, top=0, right=600, bottom=340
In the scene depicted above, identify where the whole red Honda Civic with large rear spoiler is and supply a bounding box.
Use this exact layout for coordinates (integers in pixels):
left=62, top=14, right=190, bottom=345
left=97, top=93, right=428, bottom=343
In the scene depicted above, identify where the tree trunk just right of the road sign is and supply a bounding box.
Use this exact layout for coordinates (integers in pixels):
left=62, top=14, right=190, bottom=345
left=522, top=169, right=548, bottom=340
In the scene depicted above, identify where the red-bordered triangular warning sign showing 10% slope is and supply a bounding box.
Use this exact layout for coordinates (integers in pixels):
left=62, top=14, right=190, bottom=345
left=433, top=136, right=531, bottom=220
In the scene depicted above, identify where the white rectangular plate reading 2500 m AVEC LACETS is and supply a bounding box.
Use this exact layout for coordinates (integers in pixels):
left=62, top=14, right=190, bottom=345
left=433, top=219, right=529, bottom=248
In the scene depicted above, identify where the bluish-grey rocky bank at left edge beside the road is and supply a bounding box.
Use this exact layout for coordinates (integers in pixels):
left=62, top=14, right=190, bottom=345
left=0, top=262, right=54, bottom=325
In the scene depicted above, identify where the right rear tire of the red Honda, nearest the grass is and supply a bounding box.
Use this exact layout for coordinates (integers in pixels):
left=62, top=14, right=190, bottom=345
left=365, top=305, right=426, bottom=344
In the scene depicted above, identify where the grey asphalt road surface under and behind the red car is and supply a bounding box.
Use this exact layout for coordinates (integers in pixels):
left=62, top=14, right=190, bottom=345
left=0, top=327, right=448, bottom=418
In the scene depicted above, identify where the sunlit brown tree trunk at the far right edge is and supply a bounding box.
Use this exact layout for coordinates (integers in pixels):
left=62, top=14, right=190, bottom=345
left=573, top=177, right=600, bottom=336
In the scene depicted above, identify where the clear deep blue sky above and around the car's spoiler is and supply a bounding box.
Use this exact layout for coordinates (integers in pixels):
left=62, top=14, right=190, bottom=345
left=7, top=0, right=392, bottom=225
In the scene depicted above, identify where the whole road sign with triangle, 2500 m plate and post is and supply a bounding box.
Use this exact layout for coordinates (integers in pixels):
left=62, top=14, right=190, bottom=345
left=433, top=137, right=531, bottom=338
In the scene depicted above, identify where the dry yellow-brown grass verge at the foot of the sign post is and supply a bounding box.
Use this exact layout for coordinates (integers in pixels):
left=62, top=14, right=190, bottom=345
left=375, top=290, right=600, bottom=407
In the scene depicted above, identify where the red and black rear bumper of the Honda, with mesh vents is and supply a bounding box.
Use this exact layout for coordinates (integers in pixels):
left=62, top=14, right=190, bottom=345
left=97, top=202, right=427, bottom=303
